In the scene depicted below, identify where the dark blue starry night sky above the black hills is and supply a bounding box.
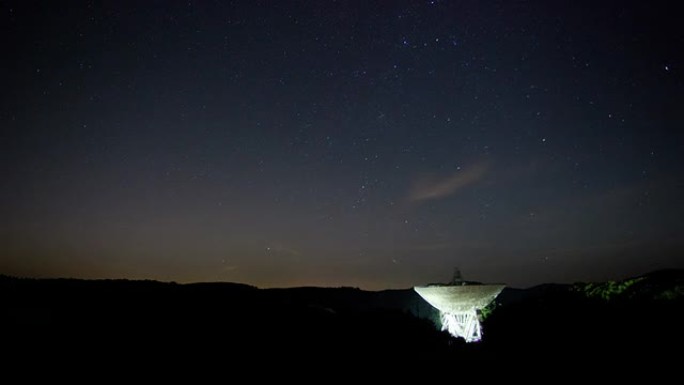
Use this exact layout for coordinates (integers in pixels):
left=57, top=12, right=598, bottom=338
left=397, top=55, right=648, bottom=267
left=0, top=0, right=684, bottom=289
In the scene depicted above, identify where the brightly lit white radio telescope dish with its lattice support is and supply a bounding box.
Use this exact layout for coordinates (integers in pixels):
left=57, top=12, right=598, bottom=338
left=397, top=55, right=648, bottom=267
left=413, top=285, right=505, bottom=342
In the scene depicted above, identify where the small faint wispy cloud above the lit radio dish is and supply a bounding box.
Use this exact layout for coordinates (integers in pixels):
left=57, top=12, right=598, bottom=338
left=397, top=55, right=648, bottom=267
left=408, top=163, right=489, bottom=202
